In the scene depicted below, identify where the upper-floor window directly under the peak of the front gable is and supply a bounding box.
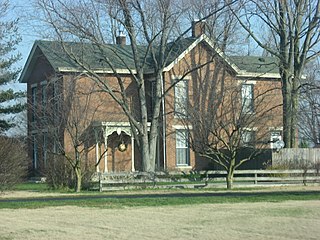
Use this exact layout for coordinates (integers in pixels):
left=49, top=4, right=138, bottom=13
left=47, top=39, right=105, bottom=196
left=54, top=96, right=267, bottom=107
left=174, top=80, right=188, bottom=117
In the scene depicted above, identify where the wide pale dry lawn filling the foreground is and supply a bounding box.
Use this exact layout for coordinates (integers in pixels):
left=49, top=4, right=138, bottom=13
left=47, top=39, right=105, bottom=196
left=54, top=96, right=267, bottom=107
left=0, top=201, right=320, bottom=240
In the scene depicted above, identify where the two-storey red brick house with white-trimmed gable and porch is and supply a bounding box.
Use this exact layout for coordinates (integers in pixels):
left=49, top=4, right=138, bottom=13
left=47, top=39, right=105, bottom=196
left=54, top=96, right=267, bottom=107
left=20, top=24, right=282, bottom=172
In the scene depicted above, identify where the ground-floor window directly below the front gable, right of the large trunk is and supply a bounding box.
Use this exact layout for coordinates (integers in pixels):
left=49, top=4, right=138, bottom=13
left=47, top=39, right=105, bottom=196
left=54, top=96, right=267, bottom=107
left=176, top=129, right=190, bottom=166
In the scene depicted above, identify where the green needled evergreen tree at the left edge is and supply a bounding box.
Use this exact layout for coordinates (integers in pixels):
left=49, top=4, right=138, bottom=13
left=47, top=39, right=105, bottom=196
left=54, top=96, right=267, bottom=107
left=0, top=1, right=25, bottom=134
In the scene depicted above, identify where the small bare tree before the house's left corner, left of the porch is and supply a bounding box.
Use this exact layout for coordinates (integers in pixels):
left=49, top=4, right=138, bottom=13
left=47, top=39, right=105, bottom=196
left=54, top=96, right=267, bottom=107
left=36, top=75, right=105, bottom=192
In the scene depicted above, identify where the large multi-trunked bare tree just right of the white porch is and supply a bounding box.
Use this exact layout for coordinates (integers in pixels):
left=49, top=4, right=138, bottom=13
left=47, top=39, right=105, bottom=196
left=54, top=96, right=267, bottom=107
left=37, top=0, right=235, bottom=172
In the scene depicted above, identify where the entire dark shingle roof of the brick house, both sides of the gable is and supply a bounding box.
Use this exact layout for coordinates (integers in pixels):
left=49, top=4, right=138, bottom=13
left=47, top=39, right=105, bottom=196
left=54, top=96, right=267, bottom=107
left=20, top=37, right=279, bottom=82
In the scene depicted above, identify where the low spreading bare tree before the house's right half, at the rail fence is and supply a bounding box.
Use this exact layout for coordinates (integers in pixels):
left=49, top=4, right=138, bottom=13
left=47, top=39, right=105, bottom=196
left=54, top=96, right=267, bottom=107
left=183, top=59, right=282, bottom=189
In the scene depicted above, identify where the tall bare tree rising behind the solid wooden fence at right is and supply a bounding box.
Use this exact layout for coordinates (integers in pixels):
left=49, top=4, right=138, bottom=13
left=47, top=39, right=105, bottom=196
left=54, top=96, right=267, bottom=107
left=231, top=0, right=320, bottom=148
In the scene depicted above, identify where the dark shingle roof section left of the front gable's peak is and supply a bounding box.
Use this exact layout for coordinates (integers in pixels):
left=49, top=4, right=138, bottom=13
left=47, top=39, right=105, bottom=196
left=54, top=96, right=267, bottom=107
left=35, top=38, right=200, bottom=70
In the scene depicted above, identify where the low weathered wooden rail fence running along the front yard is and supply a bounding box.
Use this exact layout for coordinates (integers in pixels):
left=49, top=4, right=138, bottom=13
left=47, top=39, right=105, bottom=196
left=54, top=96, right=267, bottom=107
left=97, top=169, right=320, bottom=192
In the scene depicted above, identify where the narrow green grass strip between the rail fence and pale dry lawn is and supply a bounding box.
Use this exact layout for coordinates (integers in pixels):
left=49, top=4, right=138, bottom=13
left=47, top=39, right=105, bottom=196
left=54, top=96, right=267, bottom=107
left=0, top=190, right=320, bottom=209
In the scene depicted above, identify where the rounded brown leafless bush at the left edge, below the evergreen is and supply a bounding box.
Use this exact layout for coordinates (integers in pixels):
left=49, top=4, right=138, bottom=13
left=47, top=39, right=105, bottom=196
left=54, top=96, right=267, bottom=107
left=0, top=137, right=29, bottom=191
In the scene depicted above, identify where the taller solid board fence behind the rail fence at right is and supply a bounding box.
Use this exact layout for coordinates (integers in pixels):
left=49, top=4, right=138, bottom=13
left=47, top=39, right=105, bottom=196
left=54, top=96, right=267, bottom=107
left=272, top=148, right=320, bottom=168
